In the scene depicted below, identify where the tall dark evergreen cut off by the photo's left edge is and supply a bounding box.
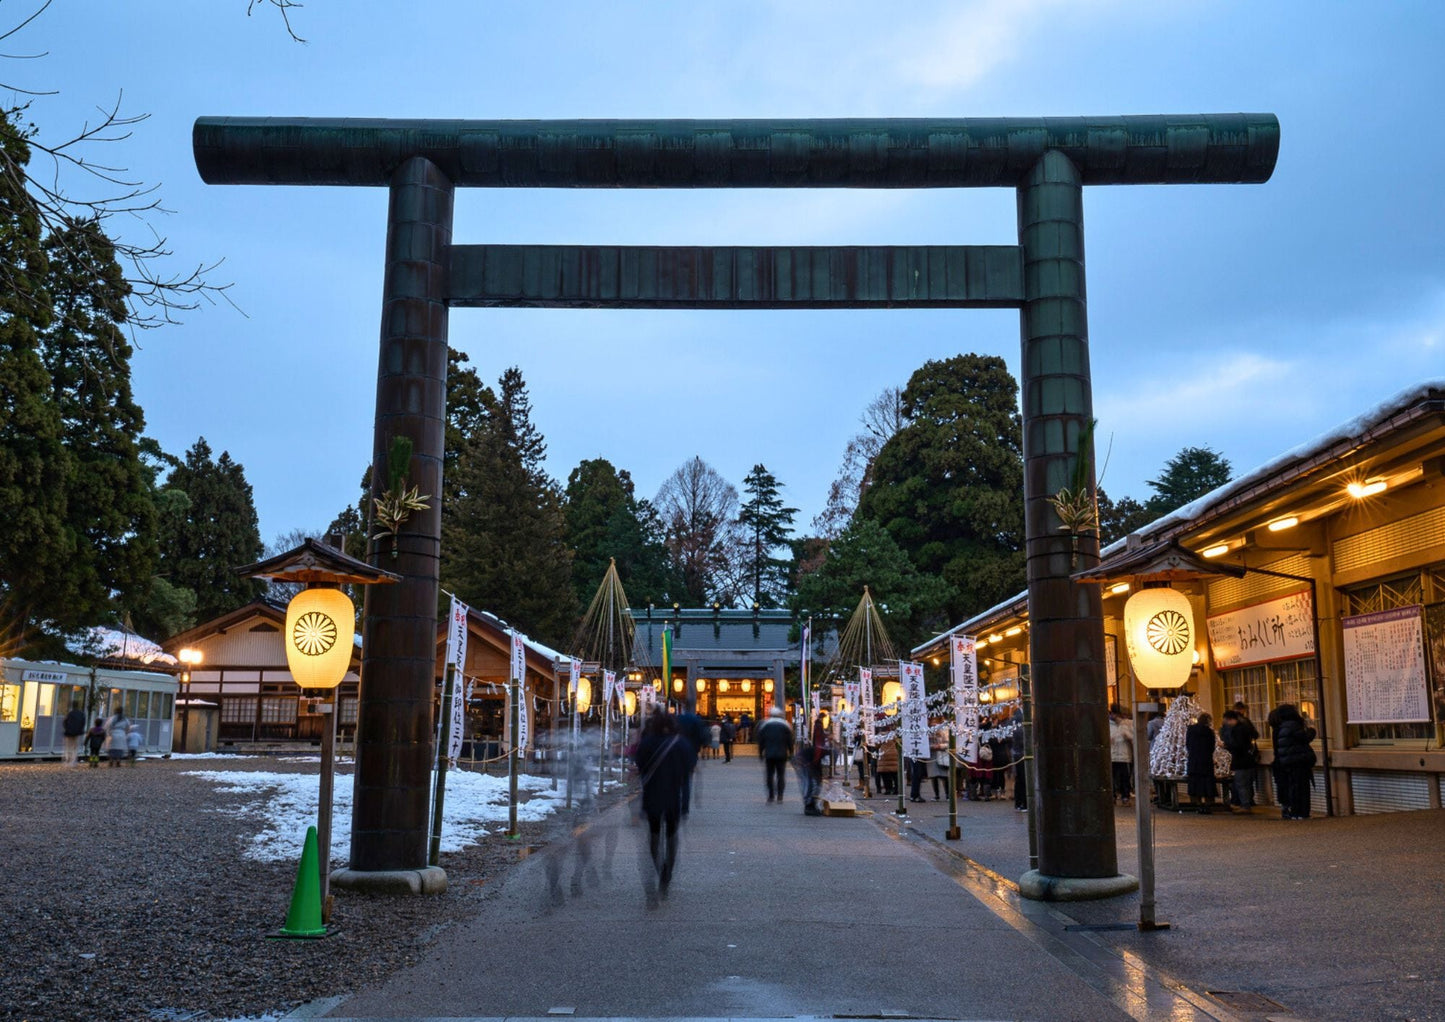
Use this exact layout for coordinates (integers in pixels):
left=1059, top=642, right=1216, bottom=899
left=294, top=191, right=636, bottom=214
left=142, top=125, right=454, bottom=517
left=0, top=111, right=67, bottom=647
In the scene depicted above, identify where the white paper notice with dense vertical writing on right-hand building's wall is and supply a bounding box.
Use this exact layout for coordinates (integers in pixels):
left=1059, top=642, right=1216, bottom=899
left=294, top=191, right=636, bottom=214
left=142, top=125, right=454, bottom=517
left=1340, top=606, right=1431, bottom=724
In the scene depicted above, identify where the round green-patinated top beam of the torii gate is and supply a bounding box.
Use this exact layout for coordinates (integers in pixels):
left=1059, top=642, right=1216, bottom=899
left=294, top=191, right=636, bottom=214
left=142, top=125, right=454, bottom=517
left=192, top=114, right=1279, bottom=188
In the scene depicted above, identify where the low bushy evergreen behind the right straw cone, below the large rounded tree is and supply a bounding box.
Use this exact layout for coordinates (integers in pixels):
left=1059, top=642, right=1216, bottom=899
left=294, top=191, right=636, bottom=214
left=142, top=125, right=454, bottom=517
left=793, top=518, right=952, bottom=646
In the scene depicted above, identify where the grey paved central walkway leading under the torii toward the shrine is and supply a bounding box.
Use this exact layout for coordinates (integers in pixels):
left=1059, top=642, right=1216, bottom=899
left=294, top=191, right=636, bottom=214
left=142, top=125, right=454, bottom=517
left=319, top=757, right=1259, bottom=1021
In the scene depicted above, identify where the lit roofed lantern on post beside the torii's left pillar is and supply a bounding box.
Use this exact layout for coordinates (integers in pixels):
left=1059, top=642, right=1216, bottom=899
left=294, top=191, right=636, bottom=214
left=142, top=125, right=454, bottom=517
left=236, top=539, right=402, bottom=935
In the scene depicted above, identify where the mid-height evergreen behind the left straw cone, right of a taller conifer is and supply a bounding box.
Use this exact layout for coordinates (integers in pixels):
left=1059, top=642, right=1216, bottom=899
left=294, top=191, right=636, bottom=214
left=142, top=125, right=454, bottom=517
left=566, top=458, right=682, bottom=607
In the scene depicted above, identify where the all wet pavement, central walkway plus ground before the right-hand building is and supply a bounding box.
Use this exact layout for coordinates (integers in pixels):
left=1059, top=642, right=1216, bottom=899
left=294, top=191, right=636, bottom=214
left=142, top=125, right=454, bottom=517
left=299, top=756, right=1445, bottom=1019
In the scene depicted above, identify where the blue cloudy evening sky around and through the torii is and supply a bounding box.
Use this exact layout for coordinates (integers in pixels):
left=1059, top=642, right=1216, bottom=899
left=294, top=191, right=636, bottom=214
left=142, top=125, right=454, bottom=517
left=14, top=0, right=1445, bottom=542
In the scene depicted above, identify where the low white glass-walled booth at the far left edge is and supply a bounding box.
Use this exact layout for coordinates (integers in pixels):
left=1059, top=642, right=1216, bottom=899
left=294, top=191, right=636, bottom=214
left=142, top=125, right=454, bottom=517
left=0, top=661, right=176, bottom=759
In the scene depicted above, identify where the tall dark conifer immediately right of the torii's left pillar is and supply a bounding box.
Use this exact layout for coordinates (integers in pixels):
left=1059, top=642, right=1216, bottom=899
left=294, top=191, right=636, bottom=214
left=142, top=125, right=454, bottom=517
left=441, top=367, right=577, bottom=645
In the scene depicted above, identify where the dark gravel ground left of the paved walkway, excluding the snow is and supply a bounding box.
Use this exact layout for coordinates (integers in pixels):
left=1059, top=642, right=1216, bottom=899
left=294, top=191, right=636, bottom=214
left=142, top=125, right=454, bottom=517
left=0, top=757, right=620, bottom=1022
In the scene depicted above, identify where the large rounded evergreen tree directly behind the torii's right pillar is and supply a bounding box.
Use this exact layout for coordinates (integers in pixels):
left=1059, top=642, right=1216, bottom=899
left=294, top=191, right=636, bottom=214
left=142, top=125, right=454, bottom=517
left=858, top=354, right=1026, bottom=620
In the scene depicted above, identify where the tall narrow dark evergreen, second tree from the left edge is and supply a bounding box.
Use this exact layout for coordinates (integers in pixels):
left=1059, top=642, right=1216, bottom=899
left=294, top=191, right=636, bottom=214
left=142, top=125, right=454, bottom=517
left=40, top=220, right=158, bottom=627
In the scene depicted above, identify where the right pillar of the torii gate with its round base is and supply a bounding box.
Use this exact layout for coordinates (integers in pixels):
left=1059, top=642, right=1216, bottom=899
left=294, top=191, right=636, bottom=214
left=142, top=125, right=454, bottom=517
left=1019, top=150, right=1139, bottom=899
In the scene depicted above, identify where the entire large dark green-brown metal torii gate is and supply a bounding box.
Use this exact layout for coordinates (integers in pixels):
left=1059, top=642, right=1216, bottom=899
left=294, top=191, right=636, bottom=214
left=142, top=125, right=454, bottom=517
left=194, top=114, right=1279, bottom=896
